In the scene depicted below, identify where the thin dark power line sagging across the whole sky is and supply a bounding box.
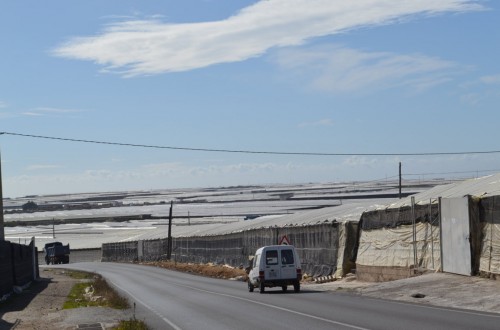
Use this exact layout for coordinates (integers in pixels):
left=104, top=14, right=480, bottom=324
left=0, top=132, right=500, bottom=156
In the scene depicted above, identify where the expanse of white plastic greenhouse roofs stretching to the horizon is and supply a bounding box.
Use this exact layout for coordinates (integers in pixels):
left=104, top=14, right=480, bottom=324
left=5, top=183, right=408, bottom=249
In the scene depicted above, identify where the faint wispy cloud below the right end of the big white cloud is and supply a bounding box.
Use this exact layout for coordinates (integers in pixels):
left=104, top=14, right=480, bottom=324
left=274, top=45, right=463, bottom=92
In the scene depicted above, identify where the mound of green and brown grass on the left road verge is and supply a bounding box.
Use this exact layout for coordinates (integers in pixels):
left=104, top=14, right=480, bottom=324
left=63, top=272, right=129, bottom=309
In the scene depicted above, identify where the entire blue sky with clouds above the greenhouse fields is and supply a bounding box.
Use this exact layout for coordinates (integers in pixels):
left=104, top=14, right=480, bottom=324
left=0, top=0, right=500, bottom=197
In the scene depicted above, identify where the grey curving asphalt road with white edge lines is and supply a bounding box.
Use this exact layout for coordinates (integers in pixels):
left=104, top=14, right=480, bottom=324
left=57, top=263, right=500, bottom=330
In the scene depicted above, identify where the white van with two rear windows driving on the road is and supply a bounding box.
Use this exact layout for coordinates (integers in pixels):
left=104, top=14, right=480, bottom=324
left=248, top=245, right=302, bottom=293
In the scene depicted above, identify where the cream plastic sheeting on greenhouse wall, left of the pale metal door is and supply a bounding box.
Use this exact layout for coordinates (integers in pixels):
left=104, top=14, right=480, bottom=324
left=356, top=223, right=441, bottom=269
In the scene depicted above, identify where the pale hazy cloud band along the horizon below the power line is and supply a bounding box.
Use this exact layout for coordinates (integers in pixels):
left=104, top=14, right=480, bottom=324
left=4, top=154, right=500, bottom=197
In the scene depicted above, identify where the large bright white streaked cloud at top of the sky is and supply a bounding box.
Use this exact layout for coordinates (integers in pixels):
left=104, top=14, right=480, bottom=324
left=53, top=0, right=483, bottom=76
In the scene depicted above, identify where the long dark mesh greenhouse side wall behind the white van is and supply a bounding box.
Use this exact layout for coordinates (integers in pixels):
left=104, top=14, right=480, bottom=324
left=102, top=222, right=357, bottom=276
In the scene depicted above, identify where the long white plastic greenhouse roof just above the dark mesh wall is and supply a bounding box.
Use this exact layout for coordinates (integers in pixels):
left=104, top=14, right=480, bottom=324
left=5, top=199, right=387, bottom=249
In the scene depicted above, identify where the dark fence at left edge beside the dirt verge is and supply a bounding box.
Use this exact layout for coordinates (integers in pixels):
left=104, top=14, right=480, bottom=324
left=0, top=241, right=39, bottom=299
